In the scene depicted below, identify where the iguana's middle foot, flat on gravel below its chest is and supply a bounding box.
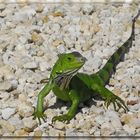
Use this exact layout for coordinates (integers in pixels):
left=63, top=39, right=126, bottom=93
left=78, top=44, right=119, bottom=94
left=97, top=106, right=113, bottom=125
left=52, top=114, right=73, bottom=123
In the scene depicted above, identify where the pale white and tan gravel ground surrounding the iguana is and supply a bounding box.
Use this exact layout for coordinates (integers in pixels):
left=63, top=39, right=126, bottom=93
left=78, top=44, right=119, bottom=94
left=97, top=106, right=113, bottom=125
left=0, top=3, right=140, bottom=136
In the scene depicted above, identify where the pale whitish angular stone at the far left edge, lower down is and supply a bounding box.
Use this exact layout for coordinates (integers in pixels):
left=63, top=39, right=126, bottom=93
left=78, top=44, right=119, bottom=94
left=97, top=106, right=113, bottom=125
left=1, top=108, right=16, bottom=120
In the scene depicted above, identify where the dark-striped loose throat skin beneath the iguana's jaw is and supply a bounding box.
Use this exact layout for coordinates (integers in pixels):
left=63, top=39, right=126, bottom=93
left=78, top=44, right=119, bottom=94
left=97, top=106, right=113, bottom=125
left=54, top=68, right=79, bottom=89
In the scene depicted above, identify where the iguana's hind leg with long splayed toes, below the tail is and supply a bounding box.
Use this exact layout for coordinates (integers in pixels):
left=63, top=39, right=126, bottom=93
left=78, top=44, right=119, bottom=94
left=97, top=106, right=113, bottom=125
left=91, top=84, right=128, bottom=112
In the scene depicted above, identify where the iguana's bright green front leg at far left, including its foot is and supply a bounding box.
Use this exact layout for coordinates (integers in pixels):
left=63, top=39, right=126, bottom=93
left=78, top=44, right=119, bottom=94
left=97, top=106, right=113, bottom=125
left=33, top=83, right=53, bottom=124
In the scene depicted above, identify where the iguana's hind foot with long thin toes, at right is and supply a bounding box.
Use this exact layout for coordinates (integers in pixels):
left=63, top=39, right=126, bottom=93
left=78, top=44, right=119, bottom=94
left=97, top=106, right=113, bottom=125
left=104, top=94, right=129, bottom=112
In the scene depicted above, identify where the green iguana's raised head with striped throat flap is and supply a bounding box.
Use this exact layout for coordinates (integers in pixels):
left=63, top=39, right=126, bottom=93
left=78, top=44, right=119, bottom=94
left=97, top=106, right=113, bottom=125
left=51, top=52, right=86, bottom=88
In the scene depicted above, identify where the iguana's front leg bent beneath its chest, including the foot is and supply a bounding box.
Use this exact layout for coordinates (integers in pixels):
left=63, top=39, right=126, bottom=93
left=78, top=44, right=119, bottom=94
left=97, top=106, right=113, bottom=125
left=52, top=90, right=80, bottom=123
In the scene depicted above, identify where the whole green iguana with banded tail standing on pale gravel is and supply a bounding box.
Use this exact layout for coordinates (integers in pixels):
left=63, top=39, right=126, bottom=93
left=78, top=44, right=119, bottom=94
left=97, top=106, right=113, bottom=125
left=34, top=10, right=140, bottom=124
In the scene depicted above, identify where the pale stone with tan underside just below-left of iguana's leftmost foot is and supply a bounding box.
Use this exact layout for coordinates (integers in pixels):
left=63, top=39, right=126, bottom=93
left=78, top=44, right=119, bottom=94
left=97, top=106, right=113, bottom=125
left=22, top=116, right=37, bottom=132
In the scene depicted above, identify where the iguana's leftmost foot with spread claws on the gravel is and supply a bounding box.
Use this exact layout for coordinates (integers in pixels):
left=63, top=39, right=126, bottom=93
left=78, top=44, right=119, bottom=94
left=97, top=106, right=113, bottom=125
left=33, top=107, right=46, bottom=125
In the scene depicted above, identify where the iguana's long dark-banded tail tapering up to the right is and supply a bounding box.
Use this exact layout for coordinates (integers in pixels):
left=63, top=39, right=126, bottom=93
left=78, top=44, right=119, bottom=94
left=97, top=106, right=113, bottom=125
left=97, top=10, right=140, bottom=84
